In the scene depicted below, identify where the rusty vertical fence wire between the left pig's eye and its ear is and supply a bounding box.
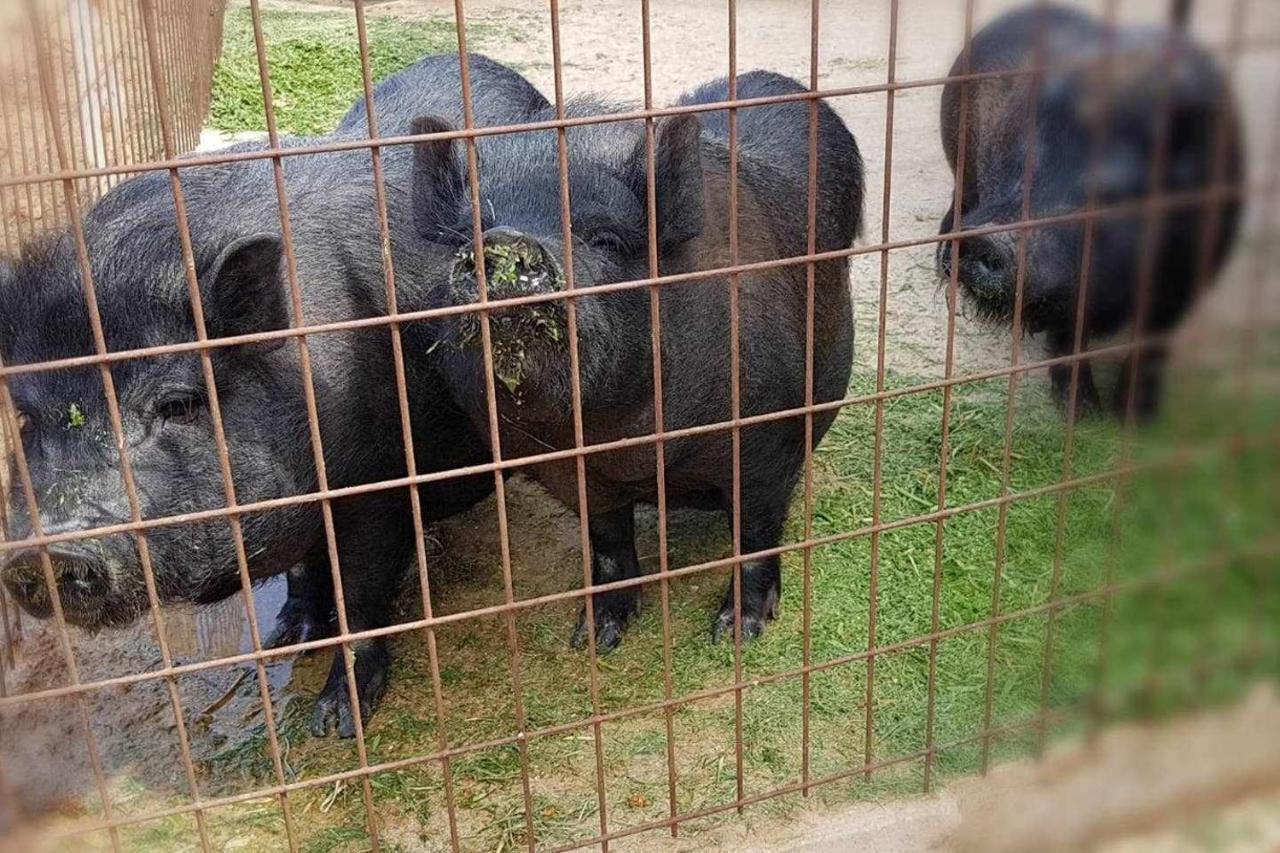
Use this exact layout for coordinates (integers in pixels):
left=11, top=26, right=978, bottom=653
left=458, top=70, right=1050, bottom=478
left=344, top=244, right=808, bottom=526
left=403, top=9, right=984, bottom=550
left=135, top=0, right=297, bottom=850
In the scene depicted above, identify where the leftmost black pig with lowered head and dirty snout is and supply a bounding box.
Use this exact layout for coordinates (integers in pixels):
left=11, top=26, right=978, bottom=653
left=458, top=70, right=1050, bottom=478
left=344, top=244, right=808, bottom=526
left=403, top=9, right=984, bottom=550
left=0, top=55, right=545, bottom=736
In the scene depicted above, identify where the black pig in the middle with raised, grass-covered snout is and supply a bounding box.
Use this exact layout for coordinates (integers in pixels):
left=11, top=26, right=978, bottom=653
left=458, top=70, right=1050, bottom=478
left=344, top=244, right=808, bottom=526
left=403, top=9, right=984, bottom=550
left=415, top=72, right=863, bottom=651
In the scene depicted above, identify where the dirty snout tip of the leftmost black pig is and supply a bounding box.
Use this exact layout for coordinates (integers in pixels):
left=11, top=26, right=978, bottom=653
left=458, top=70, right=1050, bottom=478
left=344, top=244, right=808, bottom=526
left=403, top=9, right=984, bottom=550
left=0, top=540, right=115, bottom=624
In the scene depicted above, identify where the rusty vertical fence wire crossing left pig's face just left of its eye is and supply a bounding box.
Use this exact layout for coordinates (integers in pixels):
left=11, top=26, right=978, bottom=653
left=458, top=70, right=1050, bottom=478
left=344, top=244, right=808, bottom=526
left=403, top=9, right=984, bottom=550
left=27, top=0, right=209, bottom=850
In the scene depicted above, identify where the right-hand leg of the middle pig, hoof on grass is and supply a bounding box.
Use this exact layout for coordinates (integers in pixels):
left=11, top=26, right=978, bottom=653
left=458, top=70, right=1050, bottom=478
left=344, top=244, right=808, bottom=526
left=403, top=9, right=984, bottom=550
left=712, top=471, right=795, bottom=643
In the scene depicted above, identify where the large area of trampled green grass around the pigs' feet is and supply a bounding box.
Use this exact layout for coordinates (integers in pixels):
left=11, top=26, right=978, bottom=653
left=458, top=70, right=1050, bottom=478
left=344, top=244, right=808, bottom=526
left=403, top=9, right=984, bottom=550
left=145, top=363, right=1280, bottom=850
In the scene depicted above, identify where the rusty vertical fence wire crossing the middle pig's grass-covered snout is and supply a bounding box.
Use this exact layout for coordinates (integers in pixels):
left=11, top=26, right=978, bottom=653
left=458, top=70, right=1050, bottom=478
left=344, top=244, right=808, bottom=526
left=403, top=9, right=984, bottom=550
left=453, top=6, right=538, bottom=853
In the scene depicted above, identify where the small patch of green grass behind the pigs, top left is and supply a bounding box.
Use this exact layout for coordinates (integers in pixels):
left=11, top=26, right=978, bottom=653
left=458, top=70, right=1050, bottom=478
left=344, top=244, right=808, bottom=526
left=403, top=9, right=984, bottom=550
left=210, top=6, right=504, bottom=136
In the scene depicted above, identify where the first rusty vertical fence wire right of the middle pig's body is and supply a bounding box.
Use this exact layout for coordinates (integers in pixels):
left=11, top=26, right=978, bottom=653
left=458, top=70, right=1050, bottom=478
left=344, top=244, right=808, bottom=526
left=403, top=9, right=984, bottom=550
left=863, top=0, right=906, bottom=781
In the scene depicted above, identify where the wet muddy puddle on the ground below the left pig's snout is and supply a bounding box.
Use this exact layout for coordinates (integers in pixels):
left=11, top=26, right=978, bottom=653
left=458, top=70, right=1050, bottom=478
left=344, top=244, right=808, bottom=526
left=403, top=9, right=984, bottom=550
left=0, top=576, right=311, bottom=817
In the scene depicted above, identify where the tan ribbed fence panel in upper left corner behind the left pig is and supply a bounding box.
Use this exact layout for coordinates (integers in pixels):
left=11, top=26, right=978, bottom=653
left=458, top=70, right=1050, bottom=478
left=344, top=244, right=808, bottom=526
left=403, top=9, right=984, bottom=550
left=0, top=0, right=224, bottom=690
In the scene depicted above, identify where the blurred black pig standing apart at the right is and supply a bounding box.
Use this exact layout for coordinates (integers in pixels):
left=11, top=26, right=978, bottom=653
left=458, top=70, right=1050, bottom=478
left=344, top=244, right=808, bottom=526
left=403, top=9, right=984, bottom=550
left=937, top=6, right=1243, bottom=418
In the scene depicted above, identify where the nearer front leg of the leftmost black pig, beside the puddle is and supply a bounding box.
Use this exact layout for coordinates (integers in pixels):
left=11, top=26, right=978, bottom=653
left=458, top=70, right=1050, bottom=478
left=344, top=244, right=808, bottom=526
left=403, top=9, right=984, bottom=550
left=311, top=496, right=413, bottom=738
